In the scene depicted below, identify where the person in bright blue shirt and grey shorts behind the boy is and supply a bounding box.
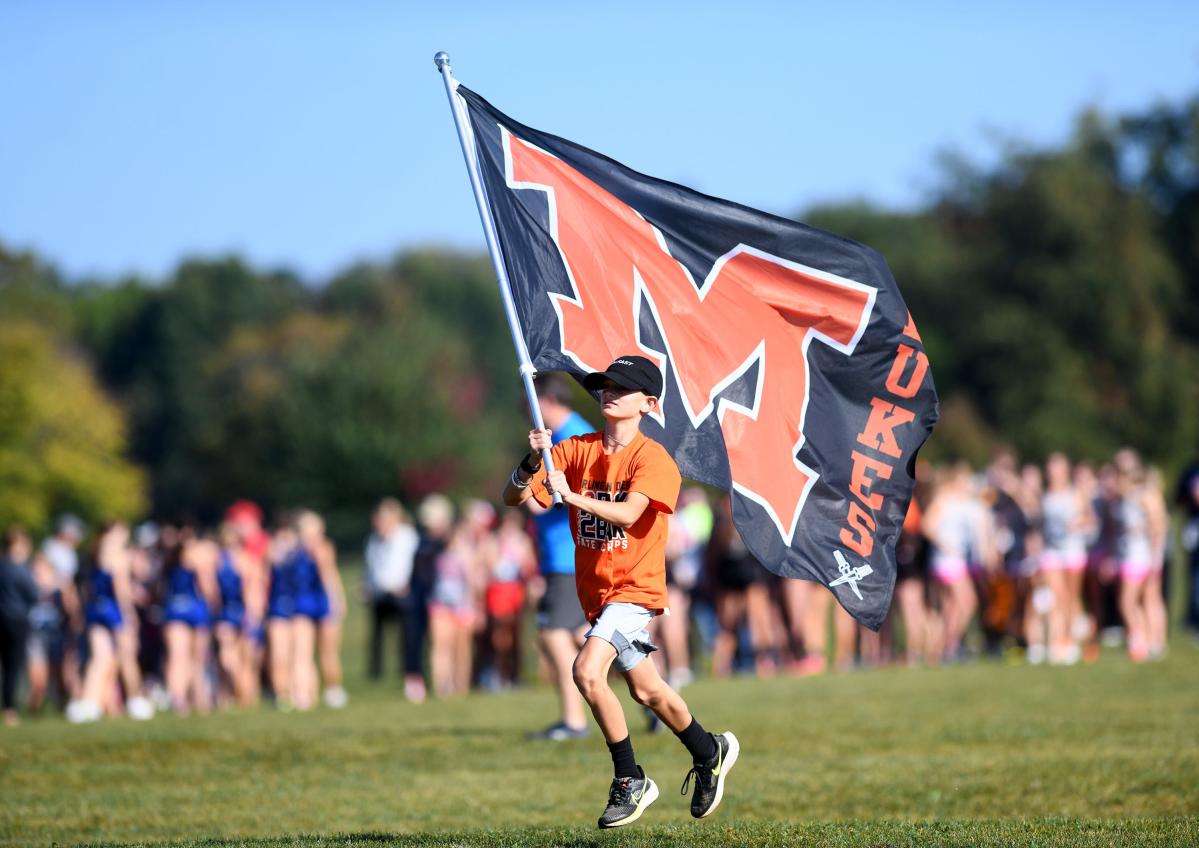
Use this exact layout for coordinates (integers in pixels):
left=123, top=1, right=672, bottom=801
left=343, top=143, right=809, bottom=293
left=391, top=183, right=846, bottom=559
left=525, top=373, right=595, bottom=741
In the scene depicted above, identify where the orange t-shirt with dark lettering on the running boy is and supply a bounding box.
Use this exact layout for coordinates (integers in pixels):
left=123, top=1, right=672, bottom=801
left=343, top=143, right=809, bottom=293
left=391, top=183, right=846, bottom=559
left=529, top=433, right=682, bottom=623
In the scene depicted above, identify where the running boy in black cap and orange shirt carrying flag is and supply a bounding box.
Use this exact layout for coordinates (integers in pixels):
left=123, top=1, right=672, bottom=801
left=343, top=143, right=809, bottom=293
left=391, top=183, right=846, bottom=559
left=504, top=356, right=740, bottom=828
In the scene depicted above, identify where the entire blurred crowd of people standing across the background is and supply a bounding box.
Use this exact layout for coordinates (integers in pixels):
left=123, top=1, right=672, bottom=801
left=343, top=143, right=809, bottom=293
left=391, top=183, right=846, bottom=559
left=0, top=381, right=1199, bottom=739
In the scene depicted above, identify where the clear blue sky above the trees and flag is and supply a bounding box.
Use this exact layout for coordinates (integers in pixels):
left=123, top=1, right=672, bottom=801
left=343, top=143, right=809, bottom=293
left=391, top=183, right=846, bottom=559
left=0, top=0, right=1199, bottom=282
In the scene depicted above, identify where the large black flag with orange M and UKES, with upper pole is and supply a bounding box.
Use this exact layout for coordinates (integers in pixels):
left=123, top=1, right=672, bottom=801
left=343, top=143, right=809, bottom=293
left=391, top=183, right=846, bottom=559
left=435, top=53, right=939, bottom=630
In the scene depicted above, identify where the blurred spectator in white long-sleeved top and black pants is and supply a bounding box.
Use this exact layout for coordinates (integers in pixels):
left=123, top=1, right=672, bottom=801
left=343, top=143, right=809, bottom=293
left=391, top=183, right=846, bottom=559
left=363, top=498, right=424, bottom=700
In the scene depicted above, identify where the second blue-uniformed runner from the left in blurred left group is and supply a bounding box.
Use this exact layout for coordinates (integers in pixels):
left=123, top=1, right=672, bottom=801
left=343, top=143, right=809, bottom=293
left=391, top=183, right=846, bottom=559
left=163, top=536, right=219, bottom=714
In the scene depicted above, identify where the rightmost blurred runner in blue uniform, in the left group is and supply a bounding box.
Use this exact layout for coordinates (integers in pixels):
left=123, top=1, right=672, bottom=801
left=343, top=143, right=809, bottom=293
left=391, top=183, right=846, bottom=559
left=293, top=510, right=348, bottom=709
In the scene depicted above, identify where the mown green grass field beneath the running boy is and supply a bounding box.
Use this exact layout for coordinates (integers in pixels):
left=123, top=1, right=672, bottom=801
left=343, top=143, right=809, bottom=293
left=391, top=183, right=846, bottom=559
left=0, top=590, right=1199, bottom=848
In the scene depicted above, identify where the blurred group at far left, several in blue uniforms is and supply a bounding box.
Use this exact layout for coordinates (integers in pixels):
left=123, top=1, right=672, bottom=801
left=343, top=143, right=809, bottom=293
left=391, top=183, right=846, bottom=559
left=0, top=501, right=348, bottom=723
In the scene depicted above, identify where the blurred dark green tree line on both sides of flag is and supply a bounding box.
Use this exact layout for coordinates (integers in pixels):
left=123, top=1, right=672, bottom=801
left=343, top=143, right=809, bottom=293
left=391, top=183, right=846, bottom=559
left=0, top=89, right=1199, bottom=530
